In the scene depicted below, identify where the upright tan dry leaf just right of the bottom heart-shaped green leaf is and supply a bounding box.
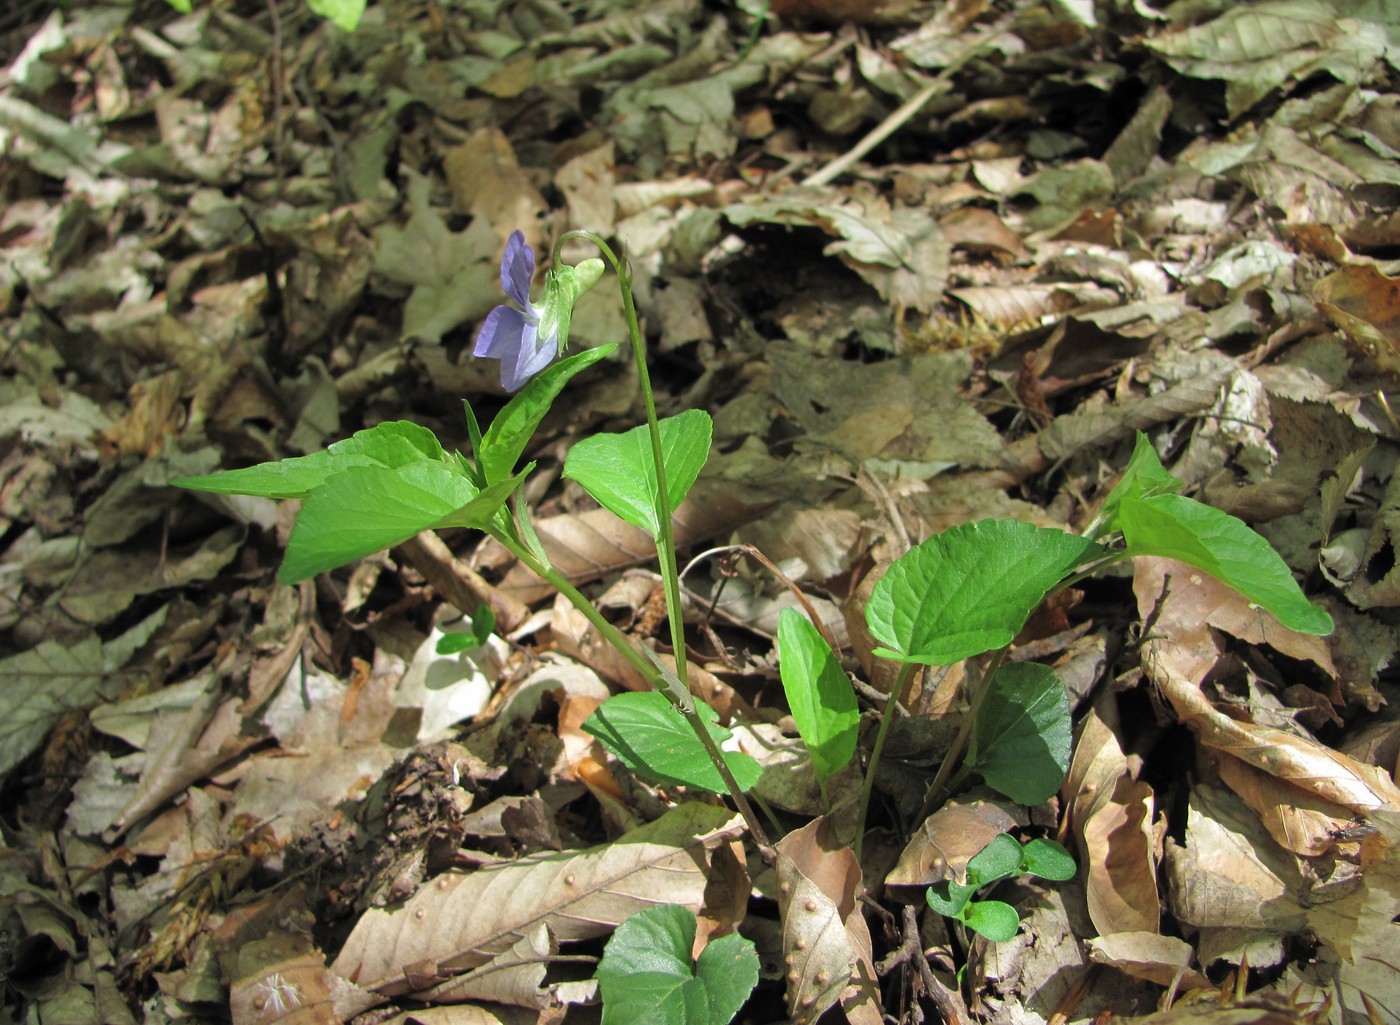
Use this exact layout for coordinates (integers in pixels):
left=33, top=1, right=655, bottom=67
left=777, top=818, right=881, bottom=1025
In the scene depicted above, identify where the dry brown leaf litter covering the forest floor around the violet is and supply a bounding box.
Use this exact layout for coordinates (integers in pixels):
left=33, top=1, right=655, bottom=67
left=0, top=0, right=1400, bottom=1025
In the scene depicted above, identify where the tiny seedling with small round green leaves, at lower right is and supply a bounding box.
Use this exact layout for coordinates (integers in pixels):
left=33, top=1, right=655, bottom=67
left=924, top=833, right=1077, bottom=942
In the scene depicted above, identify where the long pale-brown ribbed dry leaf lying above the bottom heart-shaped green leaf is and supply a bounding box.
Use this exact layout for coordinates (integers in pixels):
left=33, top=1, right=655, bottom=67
left=332, top=804, right=741, bottom=996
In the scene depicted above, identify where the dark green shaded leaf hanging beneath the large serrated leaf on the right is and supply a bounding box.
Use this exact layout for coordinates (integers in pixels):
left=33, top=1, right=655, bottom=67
left=965, top=662, right=1070, bottom=804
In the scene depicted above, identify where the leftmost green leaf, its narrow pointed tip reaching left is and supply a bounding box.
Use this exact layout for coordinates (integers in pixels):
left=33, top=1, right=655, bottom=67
left=171, top=420, right=449, bottom=498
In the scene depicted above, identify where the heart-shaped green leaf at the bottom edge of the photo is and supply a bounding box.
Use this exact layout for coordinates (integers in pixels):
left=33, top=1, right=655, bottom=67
left=596, top=905, right=759, bottom=1025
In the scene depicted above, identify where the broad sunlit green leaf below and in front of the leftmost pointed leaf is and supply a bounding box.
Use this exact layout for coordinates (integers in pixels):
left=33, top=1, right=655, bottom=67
left=277, top=462, right=525, bottom=584
